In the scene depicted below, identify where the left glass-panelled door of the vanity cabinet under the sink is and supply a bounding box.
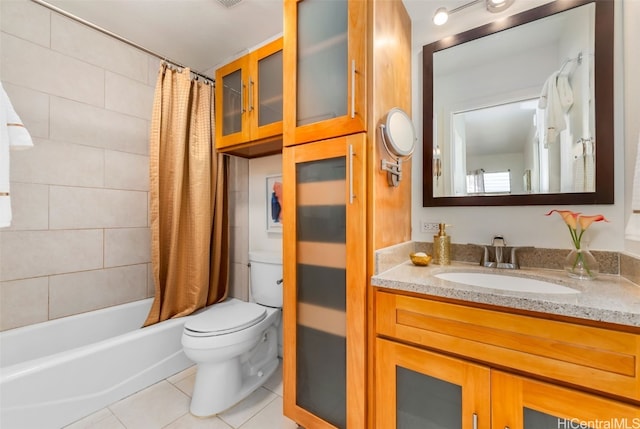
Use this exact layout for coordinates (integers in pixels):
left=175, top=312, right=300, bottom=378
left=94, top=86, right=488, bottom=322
left=376, top=338, right=491, bottom=429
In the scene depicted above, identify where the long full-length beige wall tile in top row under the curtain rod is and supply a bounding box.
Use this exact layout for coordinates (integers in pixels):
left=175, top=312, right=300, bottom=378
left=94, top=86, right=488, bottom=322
left=51, top=13, right=147, bottom=83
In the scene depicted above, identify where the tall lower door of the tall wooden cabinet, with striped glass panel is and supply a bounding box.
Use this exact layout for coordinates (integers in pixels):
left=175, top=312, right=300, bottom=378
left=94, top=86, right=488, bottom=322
left=283, top=134, right=367, bottom=429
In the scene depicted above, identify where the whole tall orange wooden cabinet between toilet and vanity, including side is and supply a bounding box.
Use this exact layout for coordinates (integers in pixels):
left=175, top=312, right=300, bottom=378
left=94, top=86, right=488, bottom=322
left=283, top=0, right=411, bottom=429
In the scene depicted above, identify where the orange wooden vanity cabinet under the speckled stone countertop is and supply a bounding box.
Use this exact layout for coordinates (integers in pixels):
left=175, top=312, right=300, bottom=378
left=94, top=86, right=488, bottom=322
left=375, top=289, right=640, bottom=429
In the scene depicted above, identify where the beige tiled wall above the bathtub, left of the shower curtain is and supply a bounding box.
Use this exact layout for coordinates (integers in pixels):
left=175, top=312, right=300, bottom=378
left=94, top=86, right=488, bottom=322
left=0, top=0, right=159, bottom=330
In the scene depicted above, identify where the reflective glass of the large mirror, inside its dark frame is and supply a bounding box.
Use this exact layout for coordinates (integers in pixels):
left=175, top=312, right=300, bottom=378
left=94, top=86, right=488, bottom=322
left=433, top=3, right=595, bottom=197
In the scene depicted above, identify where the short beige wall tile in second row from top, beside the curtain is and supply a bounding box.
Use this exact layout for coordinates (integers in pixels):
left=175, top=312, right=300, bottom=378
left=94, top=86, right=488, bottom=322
left=105, top=72, right=154, bottom=120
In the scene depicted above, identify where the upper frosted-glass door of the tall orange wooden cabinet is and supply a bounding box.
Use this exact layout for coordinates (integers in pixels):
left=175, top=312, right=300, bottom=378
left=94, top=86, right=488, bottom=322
left=284, top=0, right=369, bottom=146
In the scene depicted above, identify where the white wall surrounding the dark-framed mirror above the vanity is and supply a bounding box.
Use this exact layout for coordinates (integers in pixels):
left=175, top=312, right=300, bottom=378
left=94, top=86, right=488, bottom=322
left=412, top=0, right=640, bottom=251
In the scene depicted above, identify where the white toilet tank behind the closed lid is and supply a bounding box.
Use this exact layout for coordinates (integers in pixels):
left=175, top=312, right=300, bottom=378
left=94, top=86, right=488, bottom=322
left=249, top=251, right=283, bottom=307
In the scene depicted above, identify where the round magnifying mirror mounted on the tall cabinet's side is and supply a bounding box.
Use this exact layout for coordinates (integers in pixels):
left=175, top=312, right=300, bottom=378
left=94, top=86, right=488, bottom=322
left=380, top=107, right=416, bottom=186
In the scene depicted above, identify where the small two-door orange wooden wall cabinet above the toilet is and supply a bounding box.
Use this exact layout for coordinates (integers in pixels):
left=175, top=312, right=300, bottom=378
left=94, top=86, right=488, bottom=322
left=216, top=38, right=283, bottom=157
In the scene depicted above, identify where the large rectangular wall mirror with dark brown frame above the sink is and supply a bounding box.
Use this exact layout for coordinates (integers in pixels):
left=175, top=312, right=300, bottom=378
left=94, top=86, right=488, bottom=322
left=423, top=0, right=614, bottom=207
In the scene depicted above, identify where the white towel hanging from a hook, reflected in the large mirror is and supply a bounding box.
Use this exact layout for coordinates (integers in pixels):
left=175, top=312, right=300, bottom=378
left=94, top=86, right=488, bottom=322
left=538, top=72, right=573, bottom=148
